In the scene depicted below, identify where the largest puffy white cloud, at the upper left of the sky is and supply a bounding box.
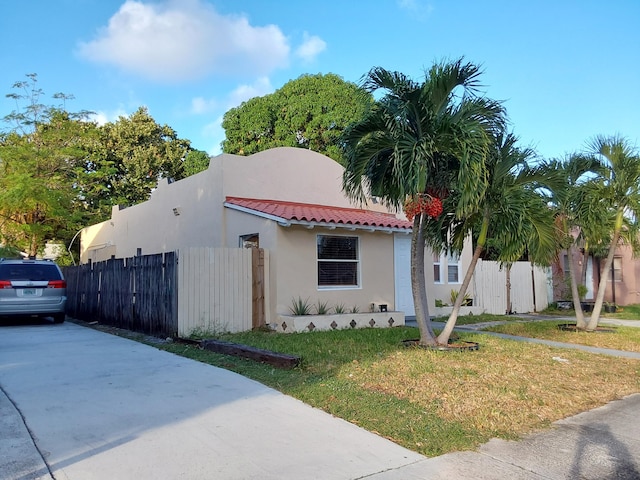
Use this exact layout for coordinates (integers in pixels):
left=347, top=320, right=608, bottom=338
left=79, top=0, right=290, bottom=82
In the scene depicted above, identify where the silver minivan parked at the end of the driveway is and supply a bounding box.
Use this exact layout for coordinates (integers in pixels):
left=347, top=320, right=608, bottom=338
left=0, top=259, right=67, bottom=323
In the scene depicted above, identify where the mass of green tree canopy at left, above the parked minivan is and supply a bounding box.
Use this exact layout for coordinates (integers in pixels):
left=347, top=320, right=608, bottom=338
left=0, top=74, right=196, bottom=255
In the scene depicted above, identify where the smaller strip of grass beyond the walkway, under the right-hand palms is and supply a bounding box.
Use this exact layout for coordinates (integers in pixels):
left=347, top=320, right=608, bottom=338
left=484, top=320, right=640, bottom=352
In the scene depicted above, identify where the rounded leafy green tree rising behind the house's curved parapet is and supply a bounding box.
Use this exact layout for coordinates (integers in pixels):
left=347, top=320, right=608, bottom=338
left=222, top=74, right=373, bottom=162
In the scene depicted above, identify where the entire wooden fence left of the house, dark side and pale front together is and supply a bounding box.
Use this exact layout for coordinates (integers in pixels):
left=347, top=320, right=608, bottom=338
left=64, top=248, right=268, bottom=337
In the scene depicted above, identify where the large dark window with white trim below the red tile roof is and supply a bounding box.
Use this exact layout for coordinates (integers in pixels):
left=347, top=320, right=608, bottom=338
left=317, top=235, right=360, bottom=288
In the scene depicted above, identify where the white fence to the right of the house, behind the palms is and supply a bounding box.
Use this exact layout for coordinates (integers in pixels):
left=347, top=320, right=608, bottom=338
left=474, top=260, right=551, bottom=315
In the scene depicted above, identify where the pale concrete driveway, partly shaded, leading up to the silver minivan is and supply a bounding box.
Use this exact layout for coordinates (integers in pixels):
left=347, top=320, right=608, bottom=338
left=0, top=323, right=425, bottom=480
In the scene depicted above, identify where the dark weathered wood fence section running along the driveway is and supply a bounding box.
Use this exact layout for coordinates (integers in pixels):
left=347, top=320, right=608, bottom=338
left=64, top=252, right=178, bottom=337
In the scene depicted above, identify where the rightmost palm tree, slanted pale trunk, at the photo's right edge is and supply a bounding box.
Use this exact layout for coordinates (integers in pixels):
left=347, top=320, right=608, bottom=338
left=587, top=136, right=640, bottom=331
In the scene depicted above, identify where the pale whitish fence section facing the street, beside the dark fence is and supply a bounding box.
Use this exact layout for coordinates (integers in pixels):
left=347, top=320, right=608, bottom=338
left=178, top=248, right=253, bottom=337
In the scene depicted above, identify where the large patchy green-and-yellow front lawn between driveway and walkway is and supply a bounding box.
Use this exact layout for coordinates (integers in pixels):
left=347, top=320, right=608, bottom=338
left=155, top=326, right=640, bottom=456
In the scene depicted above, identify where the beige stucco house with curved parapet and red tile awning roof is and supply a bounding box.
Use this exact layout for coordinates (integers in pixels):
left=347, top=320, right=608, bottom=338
left=81, top=147, right=484, bottom=328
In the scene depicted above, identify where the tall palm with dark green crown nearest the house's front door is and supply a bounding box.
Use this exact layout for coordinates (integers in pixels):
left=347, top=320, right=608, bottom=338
left=343, top=59, right=504, bottom=345
